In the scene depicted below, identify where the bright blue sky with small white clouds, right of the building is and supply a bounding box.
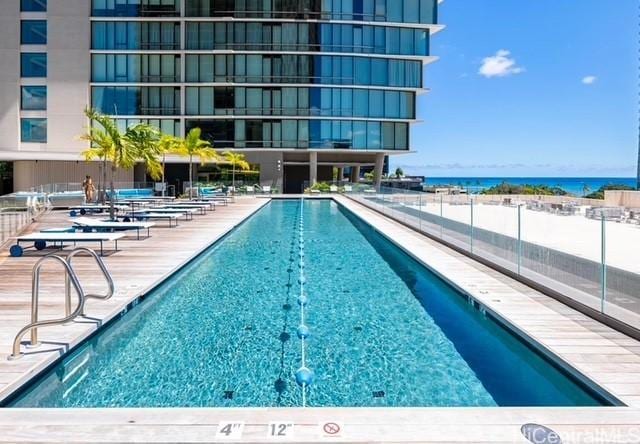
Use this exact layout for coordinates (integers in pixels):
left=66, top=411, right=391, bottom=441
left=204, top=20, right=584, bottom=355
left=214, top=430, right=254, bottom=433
left=398, top=0, right=638, bottom=177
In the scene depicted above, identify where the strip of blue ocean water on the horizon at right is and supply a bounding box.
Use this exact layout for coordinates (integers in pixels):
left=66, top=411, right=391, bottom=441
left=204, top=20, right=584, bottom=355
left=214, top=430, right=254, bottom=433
left=424, top=177, right=636, bottom=196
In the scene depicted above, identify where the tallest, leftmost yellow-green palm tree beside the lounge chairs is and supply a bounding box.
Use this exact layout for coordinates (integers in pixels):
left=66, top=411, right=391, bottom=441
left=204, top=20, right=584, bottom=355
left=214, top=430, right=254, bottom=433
left=81, top=109, right=160, bottom=220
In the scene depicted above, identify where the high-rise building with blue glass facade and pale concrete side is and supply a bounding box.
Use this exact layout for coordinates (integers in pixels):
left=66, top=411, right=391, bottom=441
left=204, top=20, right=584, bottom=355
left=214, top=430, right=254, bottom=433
left=0, top=0, right=441, bottom=192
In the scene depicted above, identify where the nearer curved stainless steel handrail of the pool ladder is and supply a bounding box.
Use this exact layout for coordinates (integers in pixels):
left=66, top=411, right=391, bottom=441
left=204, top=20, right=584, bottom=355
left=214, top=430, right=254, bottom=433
left=9, top=254, right=85, bottom=359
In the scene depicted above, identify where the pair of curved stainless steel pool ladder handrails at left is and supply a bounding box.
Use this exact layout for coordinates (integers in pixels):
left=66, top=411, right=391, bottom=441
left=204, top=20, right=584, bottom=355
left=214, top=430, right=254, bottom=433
left=9, top=247, right=115, bottom=360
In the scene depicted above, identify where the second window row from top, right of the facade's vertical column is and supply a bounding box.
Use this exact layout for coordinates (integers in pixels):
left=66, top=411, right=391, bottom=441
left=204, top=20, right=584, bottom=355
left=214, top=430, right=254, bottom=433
left=186, top=22, right=429, bottom=56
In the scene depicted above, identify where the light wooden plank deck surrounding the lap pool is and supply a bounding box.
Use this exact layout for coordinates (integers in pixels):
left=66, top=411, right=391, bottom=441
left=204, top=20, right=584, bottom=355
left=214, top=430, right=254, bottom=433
left=0, top=196, right=640, bottom=443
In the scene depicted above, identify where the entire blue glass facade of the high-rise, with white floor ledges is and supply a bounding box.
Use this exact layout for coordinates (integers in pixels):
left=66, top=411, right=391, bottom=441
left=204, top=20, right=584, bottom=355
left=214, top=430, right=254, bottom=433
left=91, top=0, right=438, bottom=151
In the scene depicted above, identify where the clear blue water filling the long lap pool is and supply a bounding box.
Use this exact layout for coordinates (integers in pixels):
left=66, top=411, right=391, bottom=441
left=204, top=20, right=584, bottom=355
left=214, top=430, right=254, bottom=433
left=11, top=200, right=604, bottom=407
